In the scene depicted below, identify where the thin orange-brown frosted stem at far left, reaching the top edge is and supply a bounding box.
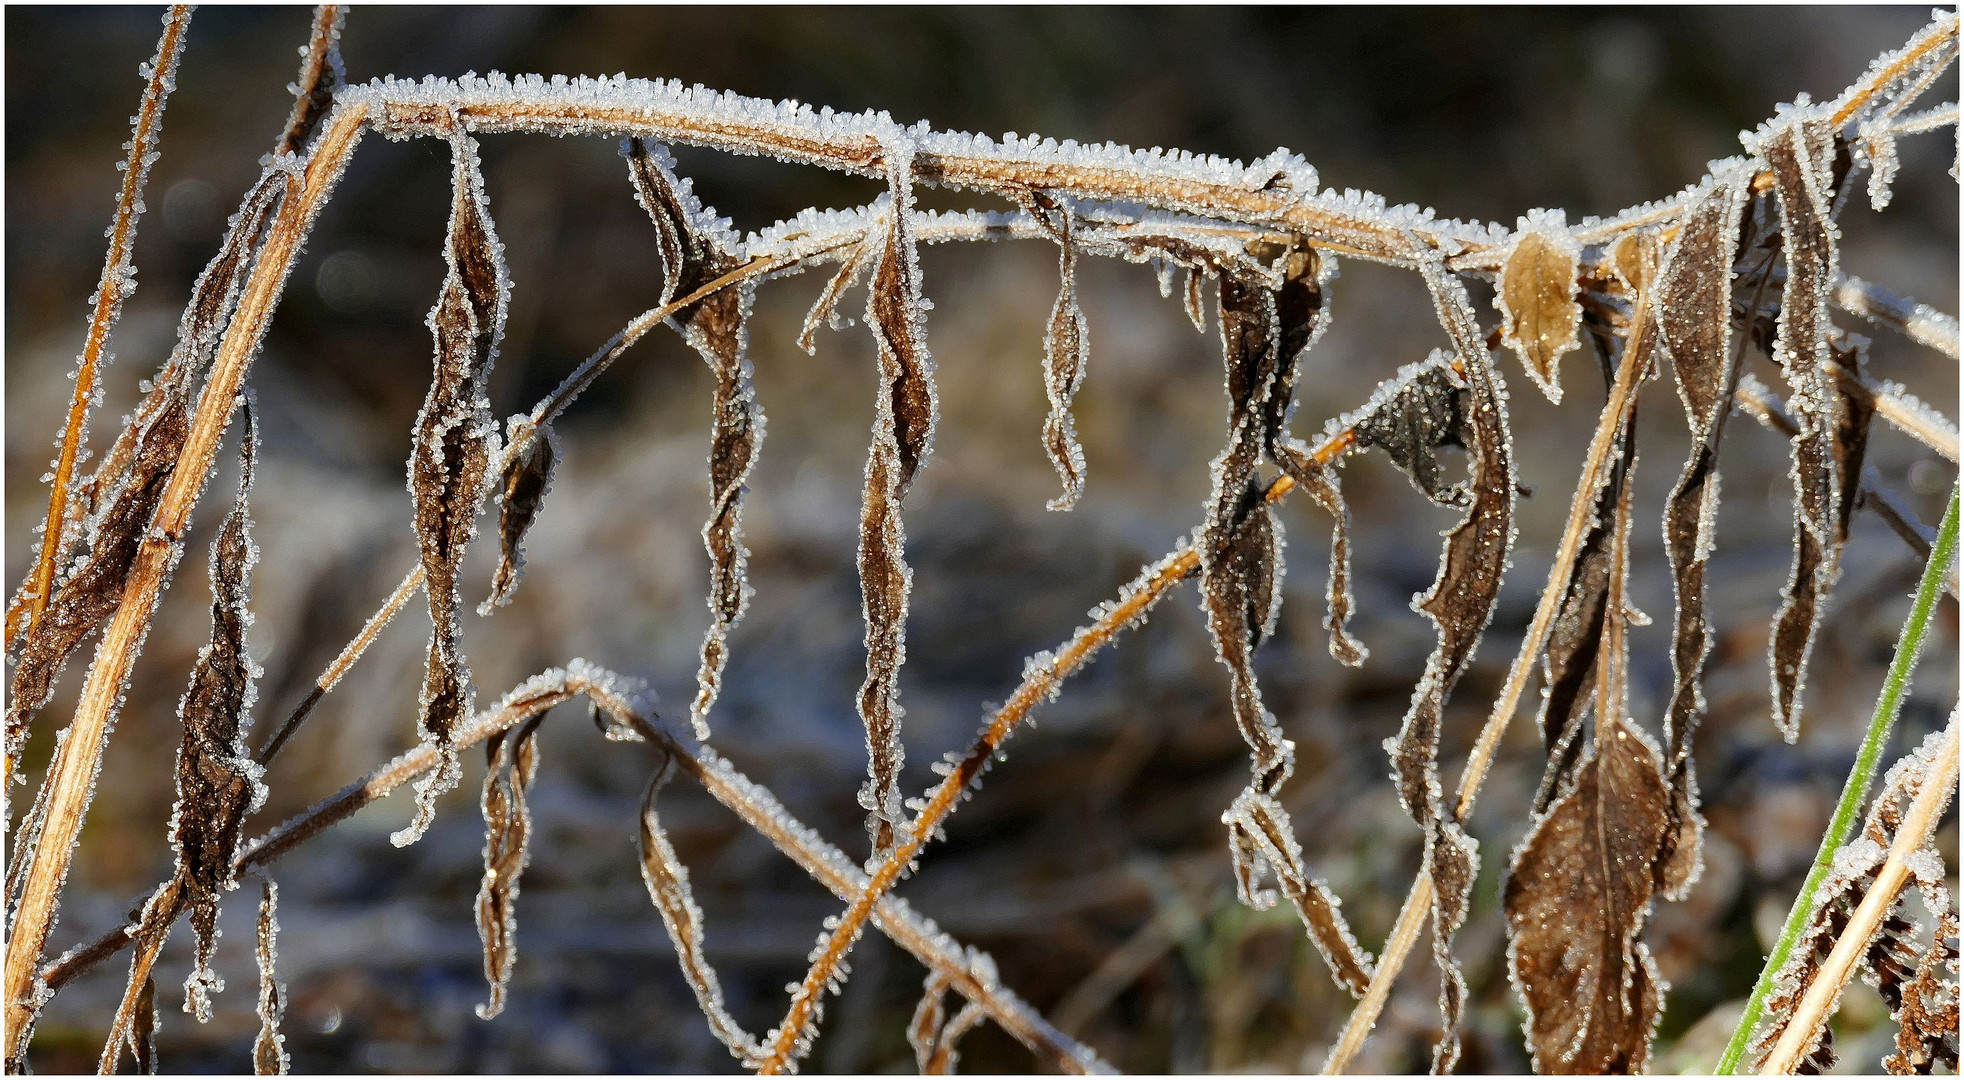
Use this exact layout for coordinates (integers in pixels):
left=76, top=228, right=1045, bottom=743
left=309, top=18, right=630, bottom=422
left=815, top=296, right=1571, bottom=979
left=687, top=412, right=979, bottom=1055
left=4, top=4, right=191, bottom=655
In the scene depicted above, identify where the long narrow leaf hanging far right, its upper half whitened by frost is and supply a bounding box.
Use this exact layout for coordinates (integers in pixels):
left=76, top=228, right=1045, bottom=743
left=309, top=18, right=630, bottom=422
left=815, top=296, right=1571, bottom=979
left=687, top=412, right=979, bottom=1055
left=1760, top=114, right=1860, bottom=742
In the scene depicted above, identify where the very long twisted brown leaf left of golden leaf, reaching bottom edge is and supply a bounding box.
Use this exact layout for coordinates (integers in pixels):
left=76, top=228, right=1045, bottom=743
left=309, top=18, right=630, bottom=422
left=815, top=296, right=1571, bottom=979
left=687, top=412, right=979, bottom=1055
left=1379, top=249, right=1514, bottom=1072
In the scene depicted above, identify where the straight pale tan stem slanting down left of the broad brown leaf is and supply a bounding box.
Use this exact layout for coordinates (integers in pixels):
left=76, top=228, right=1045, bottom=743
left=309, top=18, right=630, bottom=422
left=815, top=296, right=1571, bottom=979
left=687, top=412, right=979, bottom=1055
left=1324, top=286, right=1654, bottom=1072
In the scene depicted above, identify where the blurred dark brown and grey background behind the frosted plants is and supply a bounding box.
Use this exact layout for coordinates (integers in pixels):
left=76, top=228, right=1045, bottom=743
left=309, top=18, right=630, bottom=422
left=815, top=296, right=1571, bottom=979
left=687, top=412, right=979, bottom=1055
left=6, top=6, right=1958, bottom=1072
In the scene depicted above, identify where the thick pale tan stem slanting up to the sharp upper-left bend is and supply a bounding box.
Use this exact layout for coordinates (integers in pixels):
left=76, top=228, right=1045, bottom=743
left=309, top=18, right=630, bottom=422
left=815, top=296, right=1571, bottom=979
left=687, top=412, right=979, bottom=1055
left=4, top=108, right=363, bottom=1058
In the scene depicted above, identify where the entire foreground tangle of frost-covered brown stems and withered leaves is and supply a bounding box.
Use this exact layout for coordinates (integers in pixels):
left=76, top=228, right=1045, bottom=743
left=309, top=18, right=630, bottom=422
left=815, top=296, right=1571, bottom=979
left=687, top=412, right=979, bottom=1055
left=4, top=6, right=1958, bottom=1072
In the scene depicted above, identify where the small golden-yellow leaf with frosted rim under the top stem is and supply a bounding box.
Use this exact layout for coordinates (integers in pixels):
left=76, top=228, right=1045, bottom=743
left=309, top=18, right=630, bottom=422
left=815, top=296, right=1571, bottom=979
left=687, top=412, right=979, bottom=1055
left=1493, top=210, right=1583, bottom=403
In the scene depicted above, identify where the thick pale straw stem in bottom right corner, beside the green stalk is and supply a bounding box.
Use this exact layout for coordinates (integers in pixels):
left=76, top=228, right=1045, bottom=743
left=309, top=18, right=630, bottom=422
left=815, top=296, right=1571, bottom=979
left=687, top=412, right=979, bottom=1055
left=1760, top=713, right=1958, bottom=1076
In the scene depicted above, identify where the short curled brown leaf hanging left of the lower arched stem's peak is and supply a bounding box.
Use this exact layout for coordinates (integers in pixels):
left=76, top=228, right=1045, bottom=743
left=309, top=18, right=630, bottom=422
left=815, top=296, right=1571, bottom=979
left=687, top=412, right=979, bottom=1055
left=477, top=713, right=546, bottom=1019
